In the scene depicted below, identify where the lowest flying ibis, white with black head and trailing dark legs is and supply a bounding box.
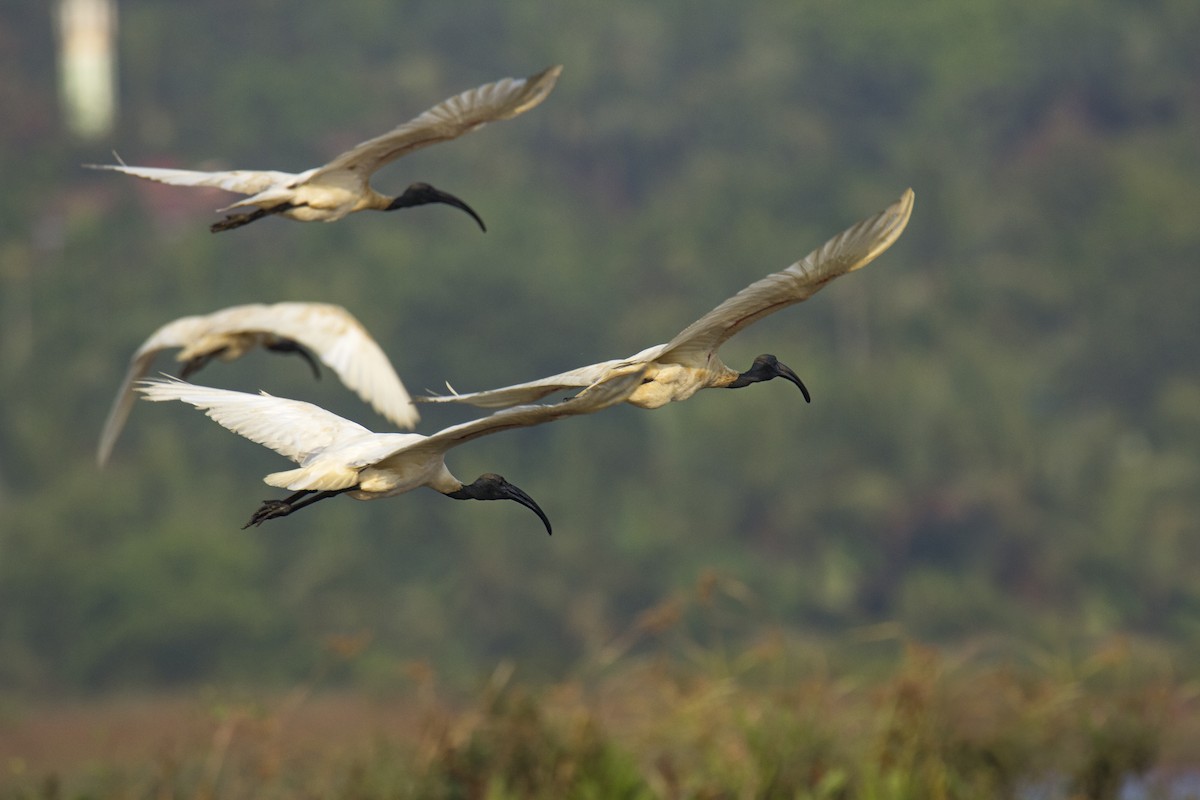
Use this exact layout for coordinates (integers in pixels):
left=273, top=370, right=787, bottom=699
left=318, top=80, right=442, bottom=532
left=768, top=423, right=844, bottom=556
left=137, top=372, right=642, bottom=534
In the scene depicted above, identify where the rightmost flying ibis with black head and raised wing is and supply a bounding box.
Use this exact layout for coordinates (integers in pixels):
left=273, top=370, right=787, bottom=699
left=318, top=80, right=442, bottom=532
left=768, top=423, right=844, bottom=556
left=414, top=190, right=913, bottom=408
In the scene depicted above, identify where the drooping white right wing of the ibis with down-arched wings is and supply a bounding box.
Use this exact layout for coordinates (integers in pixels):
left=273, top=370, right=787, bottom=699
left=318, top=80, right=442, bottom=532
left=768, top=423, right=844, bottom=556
left=213, top=302, right=420, bottom=429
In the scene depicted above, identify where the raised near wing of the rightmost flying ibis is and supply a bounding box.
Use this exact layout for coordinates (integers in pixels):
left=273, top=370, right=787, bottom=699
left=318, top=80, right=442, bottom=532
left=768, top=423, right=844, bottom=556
left=659, top=188, right=913, bottom=366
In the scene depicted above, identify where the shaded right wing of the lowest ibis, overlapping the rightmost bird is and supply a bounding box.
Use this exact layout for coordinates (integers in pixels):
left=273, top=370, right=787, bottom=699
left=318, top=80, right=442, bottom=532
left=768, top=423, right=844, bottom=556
left=386, top=368, right=646, bottom=467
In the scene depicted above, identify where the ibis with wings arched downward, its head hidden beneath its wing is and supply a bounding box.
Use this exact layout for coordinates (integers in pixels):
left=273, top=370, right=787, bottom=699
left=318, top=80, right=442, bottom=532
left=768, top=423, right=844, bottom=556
left=96, top=302, right=420, bottom=467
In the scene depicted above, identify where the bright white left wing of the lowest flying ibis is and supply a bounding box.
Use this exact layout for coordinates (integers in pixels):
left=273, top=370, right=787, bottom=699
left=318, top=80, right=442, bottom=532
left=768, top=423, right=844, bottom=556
left=137, top=378, right=371, bottom=463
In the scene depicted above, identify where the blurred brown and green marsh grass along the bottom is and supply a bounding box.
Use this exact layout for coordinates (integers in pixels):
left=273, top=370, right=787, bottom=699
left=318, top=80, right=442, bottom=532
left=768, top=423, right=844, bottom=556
left=0, top=575, right=1200, bottom=800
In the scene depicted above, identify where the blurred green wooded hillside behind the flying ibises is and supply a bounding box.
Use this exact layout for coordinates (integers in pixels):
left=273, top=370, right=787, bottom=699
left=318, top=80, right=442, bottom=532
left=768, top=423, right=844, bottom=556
left=0, top=0, right=1200, bottom=688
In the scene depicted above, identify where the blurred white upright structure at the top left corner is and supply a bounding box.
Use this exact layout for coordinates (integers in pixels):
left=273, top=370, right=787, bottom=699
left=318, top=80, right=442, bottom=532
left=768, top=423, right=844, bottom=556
left=58, top=0, right=116, bottom=139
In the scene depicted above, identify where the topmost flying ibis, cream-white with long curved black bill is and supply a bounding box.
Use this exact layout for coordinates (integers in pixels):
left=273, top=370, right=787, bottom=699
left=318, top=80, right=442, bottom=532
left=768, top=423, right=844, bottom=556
left=84, top=65, right=563, bottom=233
